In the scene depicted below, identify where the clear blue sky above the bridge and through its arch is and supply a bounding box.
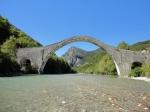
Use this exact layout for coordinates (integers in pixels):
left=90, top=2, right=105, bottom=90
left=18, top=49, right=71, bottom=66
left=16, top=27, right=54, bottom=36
left=0, top=0, right=150, bottom=55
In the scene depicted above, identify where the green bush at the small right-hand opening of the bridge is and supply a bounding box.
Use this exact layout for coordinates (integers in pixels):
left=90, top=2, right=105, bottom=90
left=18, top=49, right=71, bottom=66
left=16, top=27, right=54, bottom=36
left=129, top=67, right=143, bottom=77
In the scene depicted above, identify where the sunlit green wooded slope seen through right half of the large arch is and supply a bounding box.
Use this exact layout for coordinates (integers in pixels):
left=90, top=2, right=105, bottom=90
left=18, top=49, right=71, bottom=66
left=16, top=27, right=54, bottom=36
left=74, top=51, right=117, bottom=75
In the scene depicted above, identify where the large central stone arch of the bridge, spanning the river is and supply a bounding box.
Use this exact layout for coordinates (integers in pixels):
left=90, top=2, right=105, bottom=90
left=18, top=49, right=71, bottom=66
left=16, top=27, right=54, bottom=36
left=39, top=36, right=120, bottom=75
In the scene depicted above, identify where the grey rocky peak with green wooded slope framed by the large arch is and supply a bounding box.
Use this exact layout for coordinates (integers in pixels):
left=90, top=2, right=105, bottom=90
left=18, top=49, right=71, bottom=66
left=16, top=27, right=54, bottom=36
left=63, top=47, right=117, bottom=75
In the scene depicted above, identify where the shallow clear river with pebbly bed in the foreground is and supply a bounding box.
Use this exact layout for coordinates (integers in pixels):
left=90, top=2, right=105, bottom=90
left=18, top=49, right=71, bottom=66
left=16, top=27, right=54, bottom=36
left=0, top=74, right=150, bottom=112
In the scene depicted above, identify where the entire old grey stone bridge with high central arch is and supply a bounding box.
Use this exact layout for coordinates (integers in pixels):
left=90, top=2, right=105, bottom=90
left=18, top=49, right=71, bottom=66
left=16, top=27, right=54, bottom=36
left=16, top=36, right=150, bottom=77
